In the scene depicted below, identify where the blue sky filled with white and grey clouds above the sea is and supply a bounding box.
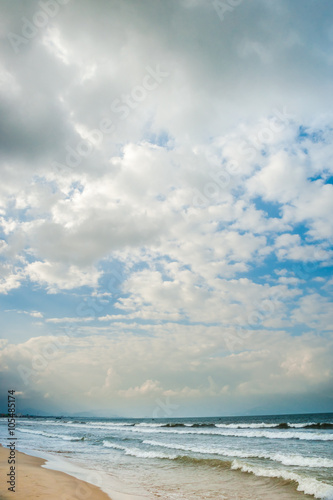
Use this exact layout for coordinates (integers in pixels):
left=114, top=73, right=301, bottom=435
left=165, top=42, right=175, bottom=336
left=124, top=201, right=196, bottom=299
left=0, top=0, right=333, bottom=418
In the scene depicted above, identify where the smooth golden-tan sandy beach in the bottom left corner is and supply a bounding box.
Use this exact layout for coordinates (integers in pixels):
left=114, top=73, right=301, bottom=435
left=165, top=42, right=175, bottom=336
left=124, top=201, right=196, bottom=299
left=0, top=447, right=110, bottom=500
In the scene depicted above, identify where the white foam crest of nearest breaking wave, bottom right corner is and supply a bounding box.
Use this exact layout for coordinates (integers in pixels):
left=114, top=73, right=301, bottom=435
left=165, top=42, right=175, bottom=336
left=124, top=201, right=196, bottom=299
left=231, top=460, right=333, bottom=500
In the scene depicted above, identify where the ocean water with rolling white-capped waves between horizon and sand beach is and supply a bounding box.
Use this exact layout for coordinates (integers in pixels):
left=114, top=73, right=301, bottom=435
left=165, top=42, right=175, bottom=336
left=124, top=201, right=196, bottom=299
left=0, top=414, right=333, bottom=500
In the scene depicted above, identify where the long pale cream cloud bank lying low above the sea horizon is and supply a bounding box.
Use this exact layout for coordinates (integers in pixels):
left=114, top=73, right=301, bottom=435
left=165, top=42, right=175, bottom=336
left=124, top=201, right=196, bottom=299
left=0, top=324, right=332, bottom=414
